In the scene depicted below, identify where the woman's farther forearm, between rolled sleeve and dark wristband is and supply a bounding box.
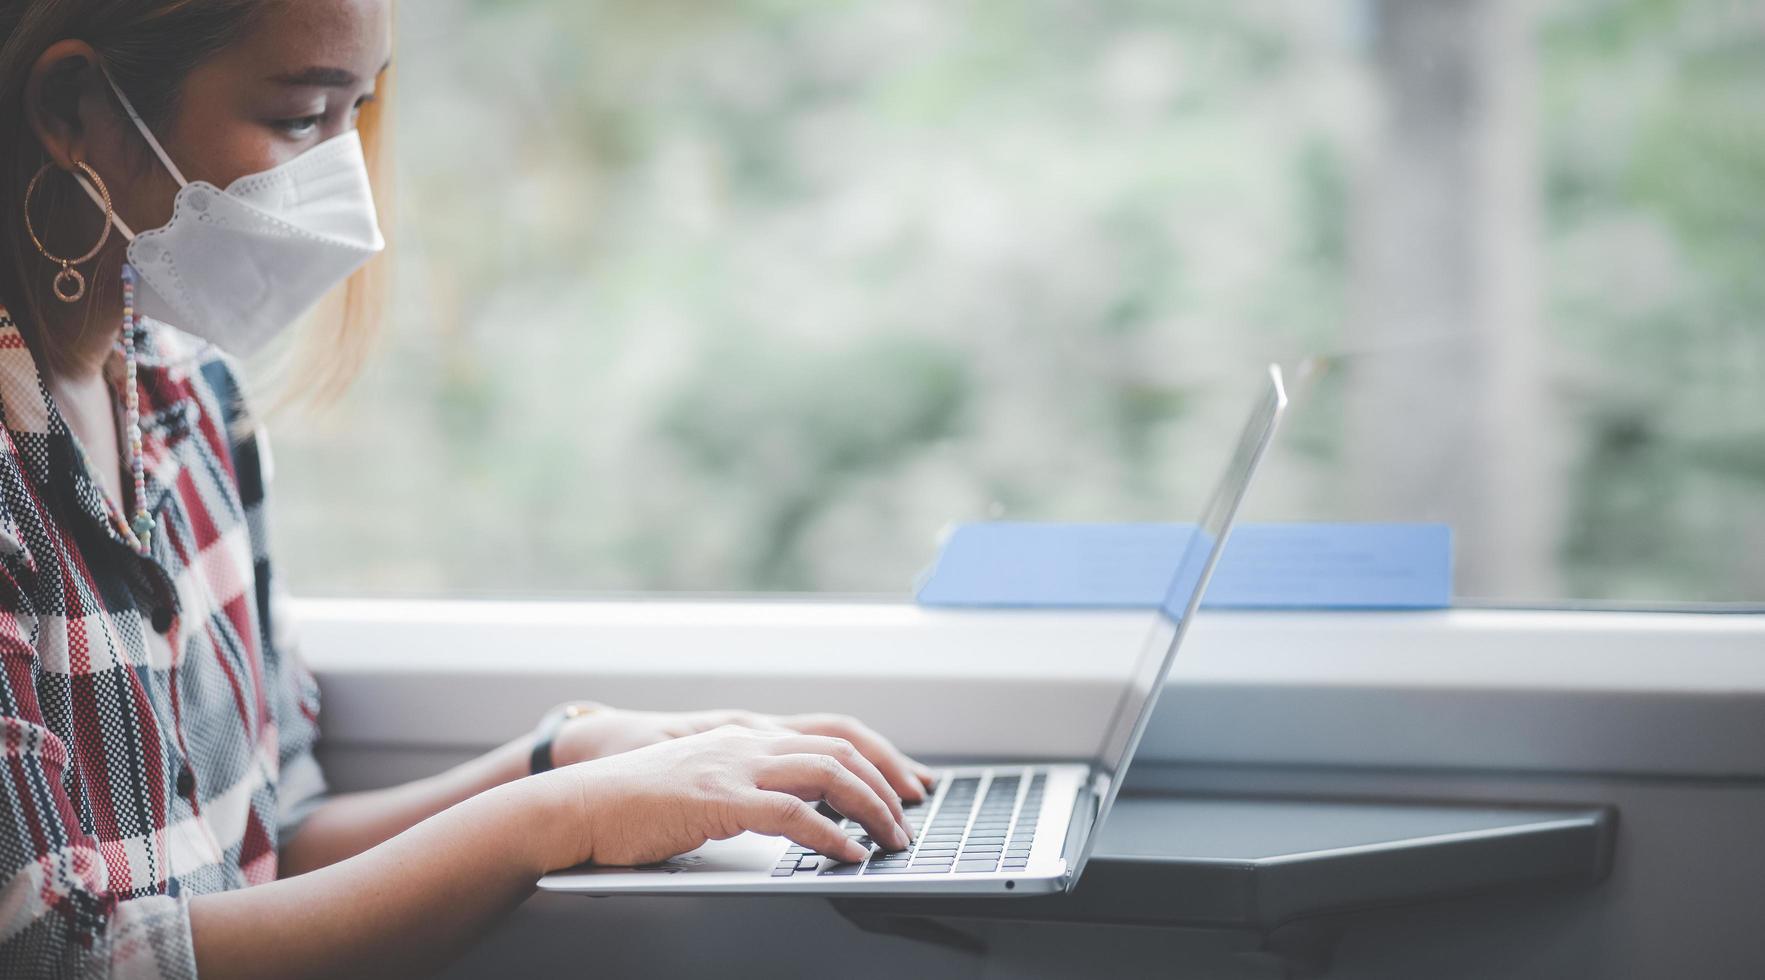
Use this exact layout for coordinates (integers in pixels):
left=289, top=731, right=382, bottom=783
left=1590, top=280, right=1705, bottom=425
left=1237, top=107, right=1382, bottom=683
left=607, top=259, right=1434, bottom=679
left=281, top=735, right=533, bottom=878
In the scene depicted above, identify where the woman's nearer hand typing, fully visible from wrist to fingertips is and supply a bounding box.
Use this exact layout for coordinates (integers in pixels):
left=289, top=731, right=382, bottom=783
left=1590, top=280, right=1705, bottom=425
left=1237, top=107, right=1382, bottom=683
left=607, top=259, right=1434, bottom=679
left=537, top=726, right=911, bottom=867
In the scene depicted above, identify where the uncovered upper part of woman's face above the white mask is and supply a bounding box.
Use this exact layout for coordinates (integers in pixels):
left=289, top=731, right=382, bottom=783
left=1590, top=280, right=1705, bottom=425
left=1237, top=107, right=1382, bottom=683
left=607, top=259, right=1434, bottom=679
left=90, top=0, right=392, bottom=230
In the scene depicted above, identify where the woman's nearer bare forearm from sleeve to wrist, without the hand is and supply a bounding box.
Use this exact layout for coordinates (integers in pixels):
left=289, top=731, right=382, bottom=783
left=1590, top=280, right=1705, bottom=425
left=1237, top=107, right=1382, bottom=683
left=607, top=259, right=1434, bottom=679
left=191, top=777, right=564, bottom=978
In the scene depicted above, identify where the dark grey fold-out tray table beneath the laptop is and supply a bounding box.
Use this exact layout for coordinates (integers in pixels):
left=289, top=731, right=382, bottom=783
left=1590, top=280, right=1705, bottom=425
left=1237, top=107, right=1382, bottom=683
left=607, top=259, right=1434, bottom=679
left=835, top=795, right=1617, bottom=964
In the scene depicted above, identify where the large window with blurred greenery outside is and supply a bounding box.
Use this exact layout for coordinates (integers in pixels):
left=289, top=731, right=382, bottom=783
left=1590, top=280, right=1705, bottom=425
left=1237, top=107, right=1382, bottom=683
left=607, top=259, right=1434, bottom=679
left=277, top=0, right=1765, bottom=602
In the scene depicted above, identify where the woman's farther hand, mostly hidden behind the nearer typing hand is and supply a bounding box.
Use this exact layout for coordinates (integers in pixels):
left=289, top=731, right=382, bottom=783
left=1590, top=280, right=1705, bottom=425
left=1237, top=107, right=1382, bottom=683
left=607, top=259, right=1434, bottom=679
left=552, top=708, right=934, bottom=812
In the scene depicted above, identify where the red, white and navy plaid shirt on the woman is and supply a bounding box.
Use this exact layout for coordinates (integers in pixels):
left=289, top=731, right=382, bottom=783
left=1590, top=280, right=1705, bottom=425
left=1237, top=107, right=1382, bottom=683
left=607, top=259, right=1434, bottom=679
left=0, top=309, right=323, bottom=978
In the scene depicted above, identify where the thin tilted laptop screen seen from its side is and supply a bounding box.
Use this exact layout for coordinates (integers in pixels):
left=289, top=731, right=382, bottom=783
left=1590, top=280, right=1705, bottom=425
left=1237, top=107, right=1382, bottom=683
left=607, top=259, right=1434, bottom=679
left=1078, top=364, right=1287, bottom=871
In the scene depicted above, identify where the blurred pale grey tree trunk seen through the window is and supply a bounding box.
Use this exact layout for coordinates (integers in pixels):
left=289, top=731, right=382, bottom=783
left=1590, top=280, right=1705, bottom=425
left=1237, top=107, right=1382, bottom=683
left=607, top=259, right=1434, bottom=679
left=1345, top=0, right=1560, bottom=595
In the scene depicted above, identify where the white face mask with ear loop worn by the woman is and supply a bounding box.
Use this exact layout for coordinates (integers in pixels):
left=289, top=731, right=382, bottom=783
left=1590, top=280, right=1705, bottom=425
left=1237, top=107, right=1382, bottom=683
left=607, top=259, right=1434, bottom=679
left=79, top=78, right=387, bottom=357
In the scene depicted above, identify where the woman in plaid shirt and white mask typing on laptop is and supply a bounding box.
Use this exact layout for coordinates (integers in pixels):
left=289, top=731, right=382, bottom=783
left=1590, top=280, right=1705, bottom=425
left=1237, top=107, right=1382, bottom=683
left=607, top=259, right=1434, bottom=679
left=0, top=0, right=930, bottom=976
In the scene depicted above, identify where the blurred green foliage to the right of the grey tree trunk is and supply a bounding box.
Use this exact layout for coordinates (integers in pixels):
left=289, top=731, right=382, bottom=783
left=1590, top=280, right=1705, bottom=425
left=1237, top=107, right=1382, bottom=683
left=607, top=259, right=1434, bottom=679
left=1543, top=0, right=1765, bottom=600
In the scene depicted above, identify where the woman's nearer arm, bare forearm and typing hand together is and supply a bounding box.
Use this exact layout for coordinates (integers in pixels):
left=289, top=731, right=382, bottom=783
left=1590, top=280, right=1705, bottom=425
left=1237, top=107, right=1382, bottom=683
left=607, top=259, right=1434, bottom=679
left=202, top=726, right=911, bottom=978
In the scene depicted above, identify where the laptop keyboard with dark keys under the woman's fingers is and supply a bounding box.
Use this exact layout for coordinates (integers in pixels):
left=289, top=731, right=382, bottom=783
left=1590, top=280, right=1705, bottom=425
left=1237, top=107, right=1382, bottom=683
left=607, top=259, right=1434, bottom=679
left=773, top=770, right=1048, bottom=878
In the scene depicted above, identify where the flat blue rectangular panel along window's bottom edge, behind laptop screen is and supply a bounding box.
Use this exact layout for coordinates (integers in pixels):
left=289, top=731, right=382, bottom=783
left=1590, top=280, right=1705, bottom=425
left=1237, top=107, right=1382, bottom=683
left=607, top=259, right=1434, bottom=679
left=918, top=521, right=1453, bottom=609
